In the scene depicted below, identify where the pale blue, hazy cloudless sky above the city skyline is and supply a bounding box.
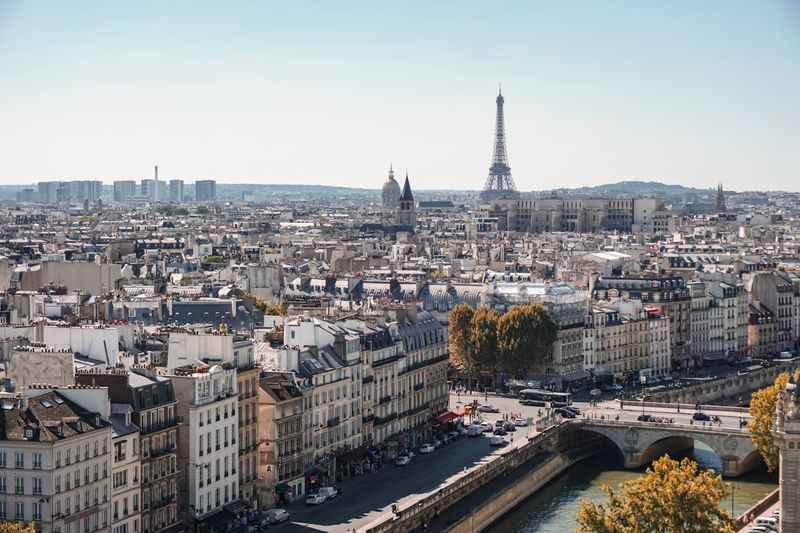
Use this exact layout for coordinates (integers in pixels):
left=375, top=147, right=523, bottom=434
left=0, top=0, right=800, bottom=190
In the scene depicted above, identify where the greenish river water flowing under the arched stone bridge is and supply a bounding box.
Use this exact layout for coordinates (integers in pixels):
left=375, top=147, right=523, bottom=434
left=487, top=443, right=778, bottom=533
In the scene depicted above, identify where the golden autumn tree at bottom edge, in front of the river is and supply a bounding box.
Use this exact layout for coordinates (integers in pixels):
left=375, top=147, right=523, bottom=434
left=577, top=455, right=736, bottom=533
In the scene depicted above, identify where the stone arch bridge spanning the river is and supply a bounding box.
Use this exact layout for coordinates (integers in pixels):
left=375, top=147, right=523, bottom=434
left=570, top=419, right=761, bottom=477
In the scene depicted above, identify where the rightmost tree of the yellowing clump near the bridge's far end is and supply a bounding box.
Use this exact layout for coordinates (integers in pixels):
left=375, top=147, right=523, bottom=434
left=497, top=305, right=558, bottom=378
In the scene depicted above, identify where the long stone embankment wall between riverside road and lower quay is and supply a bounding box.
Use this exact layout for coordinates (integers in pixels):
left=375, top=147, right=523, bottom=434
left=358, top=425, right=567, bottom=533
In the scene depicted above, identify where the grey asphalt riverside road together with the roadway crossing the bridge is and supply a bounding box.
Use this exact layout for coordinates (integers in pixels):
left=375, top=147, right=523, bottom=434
left=270, top=393, right=748, bottom=533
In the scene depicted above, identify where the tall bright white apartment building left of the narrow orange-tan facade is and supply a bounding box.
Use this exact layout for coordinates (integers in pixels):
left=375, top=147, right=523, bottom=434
left=170, top=363, right=239, bottom=531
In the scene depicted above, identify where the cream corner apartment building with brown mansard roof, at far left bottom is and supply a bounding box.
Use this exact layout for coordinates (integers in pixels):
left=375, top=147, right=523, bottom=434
left=0, top=386, right=112, bottom=533
